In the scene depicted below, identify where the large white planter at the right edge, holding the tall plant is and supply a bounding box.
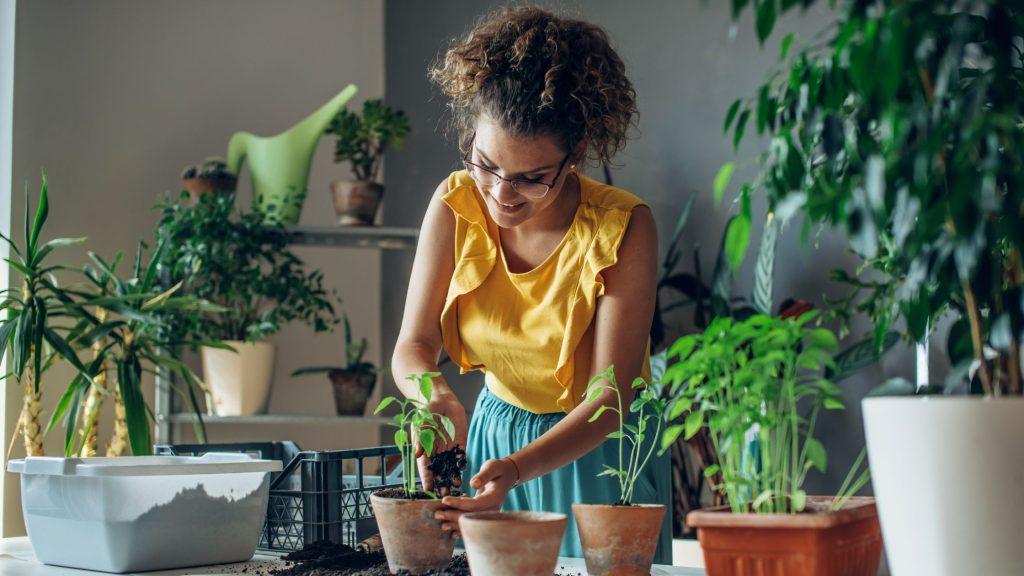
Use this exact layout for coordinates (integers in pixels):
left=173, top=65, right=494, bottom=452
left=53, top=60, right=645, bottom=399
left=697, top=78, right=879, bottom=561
left=862, top=397, right=1024, bottom=576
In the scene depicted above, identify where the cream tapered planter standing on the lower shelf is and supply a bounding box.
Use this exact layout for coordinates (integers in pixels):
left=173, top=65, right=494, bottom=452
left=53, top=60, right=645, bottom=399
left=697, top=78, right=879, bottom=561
left=201, top=340, right=275, bottom=416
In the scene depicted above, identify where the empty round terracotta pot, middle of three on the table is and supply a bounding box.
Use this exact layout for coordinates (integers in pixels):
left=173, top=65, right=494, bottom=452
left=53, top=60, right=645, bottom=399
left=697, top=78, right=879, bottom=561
left=459, top=512, right=568, bottom=576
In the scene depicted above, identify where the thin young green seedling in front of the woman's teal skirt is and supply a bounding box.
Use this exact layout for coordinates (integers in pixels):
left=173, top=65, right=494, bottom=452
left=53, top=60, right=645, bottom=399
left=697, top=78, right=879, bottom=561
left=584, top=366, right=671, bottom=505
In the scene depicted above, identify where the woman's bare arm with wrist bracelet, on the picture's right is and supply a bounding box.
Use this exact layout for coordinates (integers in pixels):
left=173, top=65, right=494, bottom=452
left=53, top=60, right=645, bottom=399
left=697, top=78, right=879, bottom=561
left=440, top=206, right=657, bottom=531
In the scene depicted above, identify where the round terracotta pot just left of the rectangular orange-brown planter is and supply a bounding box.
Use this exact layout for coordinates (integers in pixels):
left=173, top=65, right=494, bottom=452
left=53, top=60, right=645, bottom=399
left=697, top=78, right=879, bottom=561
left=572, top=504, right=665, bottom=576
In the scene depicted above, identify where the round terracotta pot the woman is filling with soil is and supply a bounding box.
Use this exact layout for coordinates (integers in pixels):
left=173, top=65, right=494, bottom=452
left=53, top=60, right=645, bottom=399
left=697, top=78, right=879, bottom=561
left=370, top=492, right=455, bottom=574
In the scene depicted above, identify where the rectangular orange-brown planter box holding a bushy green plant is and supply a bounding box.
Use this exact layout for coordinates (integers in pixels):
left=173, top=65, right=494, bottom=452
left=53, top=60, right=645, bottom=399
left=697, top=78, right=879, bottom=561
left=686, top=496, right=882, bottom=576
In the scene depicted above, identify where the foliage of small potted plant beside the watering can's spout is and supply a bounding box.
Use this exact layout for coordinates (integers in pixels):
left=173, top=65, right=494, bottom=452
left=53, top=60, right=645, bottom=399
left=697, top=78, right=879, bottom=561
left=325, top=98, right=410, bottom=181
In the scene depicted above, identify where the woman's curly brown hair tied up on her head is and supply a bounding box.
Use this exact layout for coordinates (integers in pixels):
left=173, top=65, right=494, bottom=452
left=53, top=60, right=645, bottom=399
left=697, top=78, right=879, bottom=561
left=430, top=6, right=637, bottom=164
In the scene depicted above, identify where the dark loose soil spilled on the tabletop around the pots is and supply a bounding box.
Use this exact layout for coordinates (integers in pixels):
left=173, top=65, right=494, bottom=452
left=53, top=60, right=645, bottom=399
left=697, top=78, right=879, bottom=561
left=270, top=542, right=469, bottom=576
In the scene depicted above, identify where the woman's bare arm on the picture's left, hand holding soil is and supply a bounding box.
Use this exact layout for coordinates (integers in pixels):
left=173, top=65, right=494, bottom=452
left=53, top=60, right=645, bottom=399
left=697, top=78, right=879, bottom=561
left=391, top=180, right=469, bottom=490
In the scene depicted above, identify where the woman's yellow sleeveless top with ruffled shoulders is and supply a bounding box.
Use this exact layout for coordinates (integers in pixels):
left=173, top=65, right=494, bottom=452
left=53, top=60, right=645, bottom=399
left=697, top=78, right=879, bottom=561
left=441, top=170, right=650, bottom=414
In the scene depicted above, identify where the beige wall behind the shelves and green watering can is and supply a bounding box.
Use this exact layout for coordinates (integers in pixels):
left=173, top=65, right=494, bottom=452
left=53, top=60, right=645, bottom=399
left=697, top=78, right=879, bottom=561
left=0, top=0, right=384, bottom=535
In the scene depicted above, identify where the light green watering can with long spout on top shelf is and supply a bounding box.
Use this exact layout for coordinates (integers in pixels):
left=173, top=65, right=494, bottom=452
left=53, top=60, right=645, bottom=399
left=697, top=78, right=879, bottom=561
left=227, top=84, right=357, bottom=225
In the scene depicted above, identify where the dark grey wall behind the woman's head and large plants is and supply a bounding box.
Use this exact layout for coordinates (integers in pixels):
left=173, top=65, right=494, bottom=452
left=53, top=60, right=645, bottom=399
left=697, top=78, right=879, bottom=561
left=383, top=0, right=929, bottom=493
